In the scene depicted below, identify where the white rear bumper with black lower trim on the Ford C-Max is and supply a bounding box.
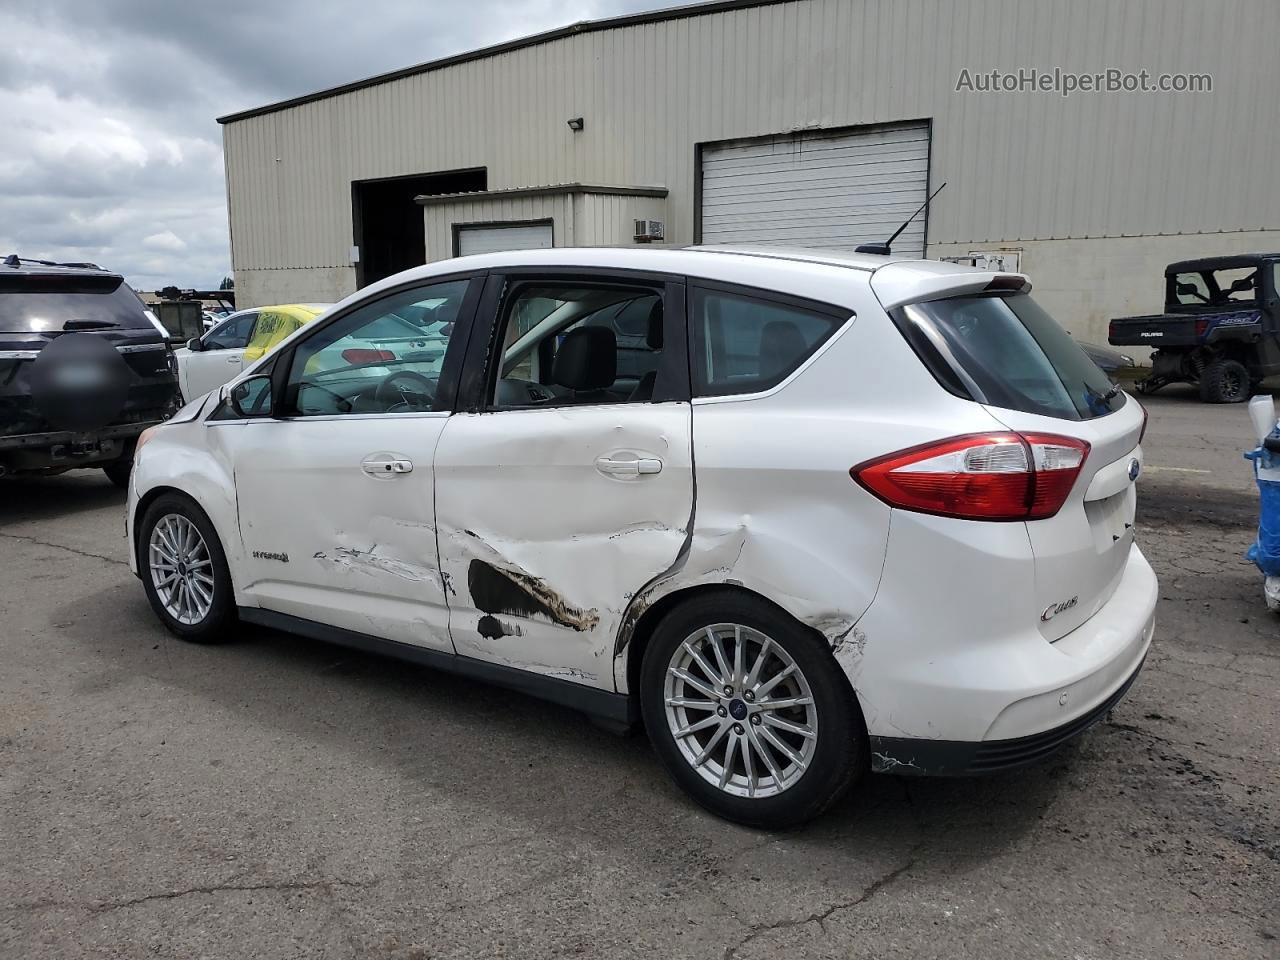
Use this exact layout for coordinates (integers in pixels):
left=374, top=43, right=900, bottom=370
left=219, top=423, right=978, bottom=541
left=850, top=547, right=1157, bottom=774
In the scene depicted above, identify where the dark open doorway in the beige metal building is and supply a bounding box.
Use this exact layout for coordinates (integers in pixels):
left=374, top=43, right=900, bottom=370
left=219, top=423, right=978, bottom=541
left=351, top=168, right=488, bottom=287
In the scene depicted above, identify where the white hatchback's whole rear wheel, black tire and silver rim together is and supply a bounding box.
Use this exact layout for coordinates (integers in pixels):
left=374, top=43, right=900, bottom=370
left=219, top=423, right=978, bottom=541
left=640, top=594, right=867, bottom=828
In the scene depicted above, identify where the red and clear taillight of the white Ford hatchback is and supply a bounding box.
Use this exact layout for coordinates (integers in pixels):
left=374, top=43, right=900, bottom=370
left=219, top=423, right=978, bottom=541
left=849, top=433, right=1089, bottom=520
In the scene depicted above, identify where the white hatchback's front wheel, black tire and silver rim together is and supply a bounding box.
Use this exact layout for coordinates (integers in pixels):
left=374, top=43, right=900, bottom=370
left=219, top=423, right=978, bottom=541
left=138, top=494, right=236, bottom=644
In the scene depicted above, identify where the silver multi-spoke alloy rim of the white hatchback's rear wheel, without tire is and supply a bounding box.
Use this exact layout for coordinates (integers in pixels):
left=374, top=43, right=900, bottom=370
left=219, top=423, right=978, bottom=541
left=663, top=623, right=818, bottom=799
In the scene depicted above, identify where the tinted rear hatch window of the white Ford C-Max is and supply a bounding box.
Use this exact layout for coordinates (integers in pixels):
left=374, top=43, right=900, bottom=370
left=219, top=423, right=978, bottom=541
left=892, top=293, right=1125, bottom=420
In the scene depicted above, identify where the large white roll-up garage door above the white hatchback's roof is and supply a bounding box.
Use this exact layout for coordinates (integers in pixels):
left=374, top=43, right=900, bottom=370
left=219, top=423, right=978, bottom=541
left=701, top=123, right=929, bottom=256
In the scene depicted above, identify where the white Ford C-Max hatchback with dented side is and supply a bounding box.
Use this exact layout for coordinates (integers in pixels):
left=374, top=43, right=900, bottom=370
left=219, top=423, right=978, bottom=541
left=128, top=248, right=1156, bottom=826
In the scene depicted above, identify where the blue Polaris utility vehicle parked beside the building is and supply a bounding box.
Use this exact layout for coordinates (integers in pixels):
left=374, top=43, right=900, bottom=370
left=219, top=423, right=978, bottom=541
left=1107, top=253, right=1280, bottom=403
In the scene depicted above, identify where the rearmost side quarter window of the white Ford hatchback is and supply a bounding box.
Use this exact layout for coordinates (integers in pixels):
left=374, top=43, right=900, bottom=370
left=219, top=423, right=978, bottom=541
left=690, top=287, right=849, bottom=397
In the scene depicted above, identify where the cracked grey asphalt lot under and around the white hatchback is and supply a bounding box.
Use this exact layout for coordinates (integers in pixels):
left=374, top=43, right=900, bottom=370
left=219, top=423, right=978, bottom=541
left=0, top=389, right=1280, bottom=960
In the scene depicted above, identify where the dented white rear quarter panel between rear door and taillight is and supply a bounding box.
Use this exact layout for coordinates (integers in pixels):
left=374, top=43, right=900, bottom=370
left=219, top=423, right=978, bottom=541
left=614, top=271, right=1018, bottom=691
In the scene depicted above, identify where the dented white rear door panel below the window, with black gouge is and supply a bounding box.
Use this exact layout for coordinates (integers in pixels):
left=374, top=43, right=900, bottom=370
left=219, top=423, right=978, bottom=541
left=435, top=402, right=694, bottom=690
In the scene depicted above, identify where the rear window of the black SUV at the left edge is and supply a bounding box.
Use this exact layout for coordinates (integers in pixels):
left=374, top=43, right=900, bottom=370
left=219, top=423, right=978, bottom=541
left=0, top=274, right=156, bottom=333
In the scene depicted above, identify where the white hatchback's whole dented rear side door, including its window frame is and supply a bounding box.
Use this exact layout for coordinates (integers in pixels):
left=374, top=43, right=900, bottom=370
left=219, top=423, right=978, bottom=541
left=435, top=275, right=694, bottom=690
